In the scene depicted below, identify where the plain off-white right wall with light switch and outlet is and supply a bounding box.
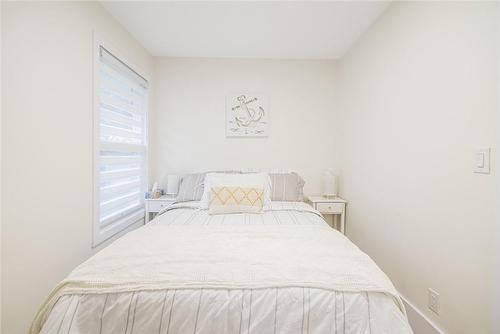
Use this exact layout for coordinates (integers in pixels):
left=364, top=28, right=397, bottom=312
left=337, top=2, right=500, bottom=334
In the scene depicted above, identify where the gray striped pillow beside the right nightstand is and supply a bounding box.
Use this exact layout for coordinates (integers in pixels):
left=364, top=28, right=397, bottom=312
left=269, top=173, right=305, bottom=202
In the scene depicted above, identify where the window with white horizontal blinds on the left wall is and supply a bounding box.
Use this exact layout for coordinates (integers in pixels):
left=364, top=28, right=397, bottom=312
left=93, top=39, right=148, bottom=246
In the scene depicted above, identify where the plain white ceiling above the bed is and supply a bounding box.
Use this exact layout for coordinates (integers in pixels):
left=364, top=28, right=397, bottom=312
left=101, top=1, right=389, bottom=59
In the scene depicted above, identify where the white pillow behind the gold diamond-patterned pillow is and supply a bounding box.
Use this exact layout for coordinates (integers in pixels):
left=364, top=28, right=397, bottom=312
left=200, top=173, right=271, bottom=209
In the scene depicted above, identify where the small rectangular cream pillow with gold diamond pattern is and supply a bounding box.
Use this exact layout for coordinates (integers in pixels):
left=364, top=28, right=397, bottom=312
left=208, top=186, right=264, bottom=215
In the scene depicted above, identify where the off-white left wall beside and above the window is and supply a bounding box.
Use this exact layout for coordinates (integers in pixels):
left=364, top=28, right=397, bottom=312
left=2, top=2, right=152, bottom=334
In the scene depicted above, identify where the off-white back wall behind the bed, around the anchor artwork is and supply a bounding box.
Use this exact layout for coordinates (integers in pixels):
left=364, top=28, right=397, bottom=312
left=151, top=58, right=336, bottom=193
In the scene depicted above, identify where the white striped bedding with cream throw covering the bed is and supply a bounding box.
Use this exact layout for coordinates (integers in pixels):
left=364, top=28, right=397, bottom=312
left=31, top=202, right=411, bottom=334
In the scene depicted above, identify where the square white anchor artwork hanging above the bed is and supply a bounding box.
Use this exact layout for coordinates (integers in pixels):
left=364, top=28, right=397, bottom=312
left=226, top=92, right=269, bottom=137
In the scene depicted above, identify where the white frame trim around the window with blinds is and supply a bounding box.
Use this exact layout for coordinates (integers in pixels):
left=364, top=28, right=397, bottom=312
left=92, top=31, right=151, bottom=248
